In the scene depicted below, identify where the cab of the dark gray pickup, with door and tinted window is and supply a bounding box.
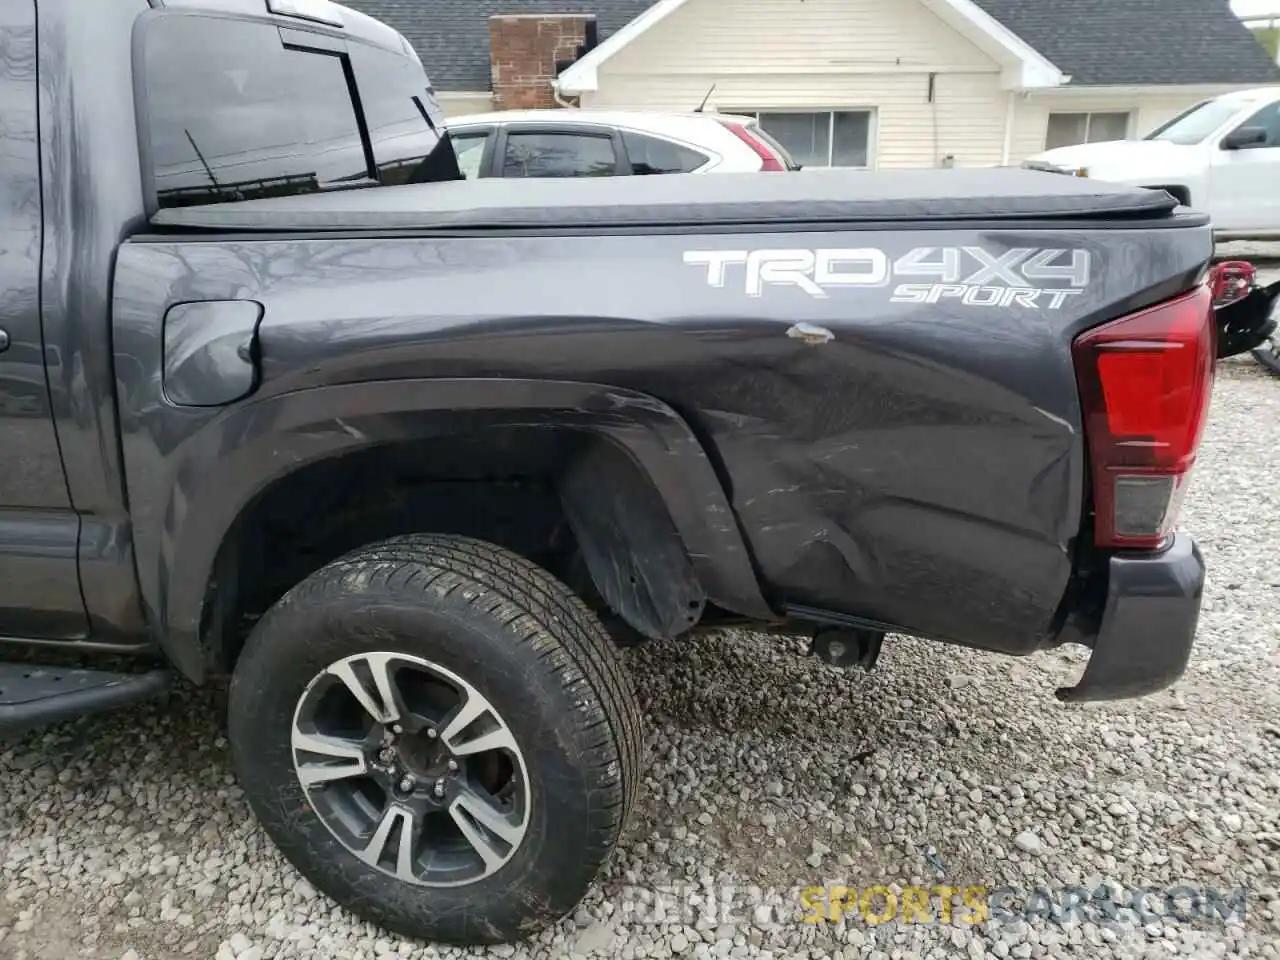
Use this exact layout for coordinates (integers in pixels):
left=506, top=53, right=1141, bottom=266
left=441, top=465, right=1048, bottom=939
left=0, top=0, right=461, bottom=648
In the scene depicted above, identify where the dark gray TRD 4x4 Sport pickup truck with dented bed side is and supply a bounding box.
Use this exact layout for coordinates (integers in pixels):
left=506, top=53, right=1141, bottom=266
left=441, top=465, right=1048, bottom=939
left=0, top=0, right=1215, bottom=943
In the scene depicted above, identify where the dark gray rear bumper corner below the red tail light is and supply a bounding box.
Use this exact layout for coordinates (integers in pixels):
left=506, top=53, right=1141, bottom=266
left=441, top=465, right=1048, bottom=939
left=1057, top=532, right=1204, bottom=703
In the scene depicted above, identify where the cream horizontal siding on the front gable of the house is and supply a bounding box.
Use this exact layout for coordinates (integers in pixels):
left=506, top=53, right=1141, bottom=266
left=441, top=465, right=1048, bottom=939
left=581, top=0, right=1007, bottom=168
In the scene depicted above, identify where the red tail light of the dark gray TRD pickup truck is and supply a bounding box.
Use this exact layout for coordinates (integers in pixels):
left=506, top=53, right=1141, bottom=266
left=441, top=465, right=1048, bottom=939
left=1071, top=284, right=1215, bottom=549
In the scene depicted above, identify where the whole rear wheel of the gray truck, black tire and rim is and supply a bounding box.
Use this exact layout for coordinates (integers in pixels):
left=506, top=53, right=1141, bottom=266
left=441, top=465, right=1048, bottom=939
left=228, top=535, right=641, bottom=945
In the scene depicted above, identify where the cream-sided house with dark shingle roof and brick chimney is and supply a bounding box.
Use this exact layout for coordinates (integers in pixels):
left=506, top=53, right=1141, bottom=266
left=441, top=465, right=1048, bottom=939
left=347, top=0, right=1280, bottom=168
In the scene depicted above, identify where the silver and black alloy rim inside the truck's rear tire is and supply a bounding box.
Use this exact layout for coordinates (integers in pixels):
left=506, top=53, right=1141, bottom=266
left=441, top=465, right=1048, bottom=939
left=292, top=653, right=530, bottom=887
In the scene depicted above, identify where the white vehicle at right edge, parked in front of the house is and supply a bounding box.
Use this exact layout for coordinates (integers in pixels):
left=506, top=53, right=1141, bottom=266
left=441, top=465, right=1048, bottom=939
left=1024, top=87, right=1280, bottom=239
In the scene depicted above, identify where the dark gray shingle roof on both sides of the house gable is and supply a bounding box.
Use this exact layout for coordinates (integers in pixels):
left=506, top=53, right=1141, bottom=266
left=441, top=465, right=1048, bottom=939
left=343, top=0, right=1280, bottom=91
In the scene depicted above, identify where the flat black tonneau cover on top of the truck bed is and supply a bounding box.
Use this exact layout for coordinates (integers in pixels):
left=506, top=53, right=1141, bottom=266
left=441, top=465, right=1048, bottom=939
left=152, top=168, right=1176, bottom=230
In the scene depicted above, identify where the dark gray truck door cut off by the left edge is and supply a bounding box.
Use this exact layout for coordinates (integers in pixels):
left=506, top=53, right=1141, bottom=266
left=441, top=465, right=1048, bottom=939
left=0, top=0, right=87, bottom=639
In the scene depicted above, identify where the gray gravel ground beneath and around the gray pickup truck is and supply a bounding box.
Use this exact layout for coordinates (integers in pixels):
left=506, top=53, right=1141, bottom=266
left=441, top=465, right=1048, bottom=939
left=0, top=361, right=1280, bottom=960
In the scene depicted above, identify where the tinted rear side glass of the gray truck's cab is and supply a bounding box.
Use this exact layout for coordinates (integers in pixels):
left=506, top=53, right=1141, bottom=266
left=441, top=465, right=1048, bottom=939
left=143, top=14, right=458, bottom=207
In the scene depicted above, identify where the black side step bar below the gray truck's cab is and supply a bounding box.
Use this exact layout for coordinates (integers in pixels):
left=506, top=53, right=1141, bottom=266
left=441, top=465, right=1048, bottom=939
left=0, top=663, right=172, bottom=733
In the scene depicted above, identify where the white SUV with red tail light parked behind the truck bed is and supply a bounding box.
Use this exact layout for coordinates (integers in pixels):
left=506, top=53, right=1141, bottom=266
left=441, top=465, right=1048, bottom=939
left=447, top=110, right=800, bottom=179
